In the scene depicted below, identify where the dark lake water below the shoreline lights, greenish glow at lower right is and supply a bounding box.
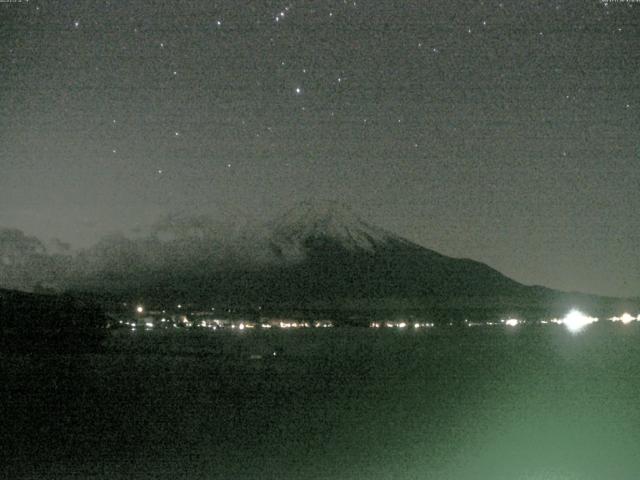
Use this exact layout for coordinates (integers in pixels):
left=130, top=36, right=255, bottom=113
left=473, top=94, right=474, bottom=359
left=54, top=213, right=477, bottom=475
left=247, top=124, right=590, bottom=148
left=0, top=325, right=640, bottom=480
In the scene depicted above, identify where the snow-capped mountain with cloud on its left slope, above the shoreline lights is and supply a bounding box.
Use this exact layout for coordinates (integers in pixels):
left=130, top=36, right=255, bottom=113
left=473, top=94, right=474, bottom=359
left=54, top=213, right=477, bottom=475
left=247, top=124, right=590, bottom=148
left=5, top=202, right=636, bottom=313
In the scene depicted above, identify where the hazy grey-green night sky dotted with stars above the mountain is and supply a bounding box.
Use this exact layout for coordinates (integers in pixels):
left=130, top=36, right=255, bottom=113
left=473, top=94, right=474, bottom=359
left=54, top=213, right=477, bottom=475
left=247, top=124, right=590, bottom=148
left=0, top=0, right=640, bottom=295
